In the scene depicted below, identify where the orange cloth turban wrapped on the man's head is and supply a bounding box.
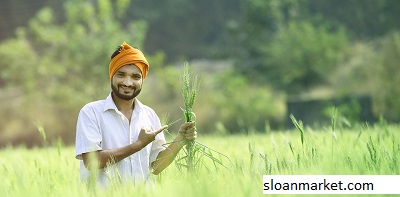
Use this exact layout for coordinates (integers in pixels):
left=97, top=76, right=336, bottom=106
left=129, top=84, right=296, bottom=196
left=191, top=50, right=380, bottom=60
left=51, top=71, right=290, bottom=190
left=109, top=42, right=150, bottom=80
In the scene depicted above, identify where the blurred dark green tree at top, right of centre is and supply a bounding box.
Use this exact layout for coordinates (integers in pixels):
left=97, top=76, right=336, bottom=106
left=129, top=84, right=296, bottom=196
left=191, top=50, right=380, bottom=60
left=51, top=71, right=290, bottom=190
left=233, top=0, right=347, bottom=94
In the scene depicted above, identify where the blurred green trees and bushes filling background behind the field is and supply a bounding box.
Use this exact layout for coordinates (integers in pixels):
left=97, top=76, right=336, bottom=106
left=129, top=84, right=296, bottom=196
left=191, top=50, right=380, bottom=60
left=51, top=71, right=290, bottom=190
left=0, top=0, right=400, bottom=146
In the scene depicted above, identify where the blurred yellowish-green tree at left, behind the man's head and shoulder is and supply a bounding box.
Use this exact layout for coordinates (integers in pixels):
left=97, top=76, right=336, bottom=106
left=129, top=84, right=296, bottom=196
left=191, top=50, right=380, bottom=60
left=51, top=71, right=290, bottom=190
left=0, top=0, right=146, bottom=143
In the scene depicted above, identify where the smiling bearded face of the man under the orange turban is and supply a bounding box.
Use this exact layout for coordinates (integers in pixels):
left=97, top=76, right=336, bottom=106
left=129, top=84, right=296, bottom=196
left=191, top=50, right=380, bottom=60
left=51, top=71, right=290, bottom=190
left=111, top=64, right=143, bottom=100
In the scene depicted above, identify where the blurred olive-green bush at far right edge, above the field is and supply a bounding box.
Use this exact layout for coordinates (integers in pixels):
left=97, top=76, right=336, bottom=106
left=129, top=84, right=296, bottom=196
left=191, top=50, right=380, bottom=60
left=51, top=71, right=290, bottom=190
left=328, top=33, right=400, bottom=122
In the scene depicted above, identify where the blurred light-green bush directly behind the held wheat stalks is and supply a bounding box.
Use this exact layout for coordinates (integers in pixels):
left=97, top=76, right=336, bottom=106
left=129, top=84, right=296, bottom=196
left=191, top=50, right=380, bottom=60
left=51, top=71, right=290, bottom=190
left=142, top=64, right=285, bottom=135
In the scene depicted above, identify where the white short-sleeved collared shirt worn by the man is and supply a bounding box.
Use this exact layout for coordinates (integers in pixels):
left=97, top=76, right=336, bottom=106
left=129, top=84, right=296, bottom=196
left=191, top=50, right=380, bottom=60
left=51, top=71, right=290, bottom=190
left=75, top=93, right=166, bottom=186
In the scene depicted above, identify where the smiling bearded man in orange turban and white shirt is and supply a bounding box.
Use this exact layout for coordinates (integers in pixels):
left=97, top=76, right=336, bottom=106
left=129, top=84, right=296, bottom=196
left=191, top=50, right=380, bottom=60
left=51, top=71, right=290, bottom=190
left=76, top=42, right=196, bottom=185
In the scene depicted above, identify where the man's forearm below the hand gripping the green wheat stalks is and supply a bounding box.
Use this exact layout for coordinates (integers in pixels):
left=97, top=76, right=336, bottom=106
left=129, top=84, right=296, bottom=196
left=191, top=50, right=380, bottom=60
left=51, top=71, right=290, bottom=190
left=151, top=135, right=185, bottom=175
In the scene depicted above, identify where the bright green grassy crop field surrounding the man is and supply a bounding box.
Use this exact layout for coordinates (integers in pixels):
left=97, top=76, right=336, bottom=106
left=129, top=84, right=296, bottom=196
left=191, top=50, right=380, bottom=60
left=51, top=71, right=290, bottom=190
left=0, top=124, right=400, bottom=197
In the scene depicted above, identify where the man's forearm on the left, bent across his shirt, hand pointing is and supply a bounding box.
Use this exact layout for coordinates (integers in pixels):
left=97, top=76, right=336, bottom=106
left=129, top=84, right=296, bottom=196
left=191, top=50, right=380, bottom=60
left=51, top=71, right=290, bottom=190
left=82, top=141, right=144, bottom=169
